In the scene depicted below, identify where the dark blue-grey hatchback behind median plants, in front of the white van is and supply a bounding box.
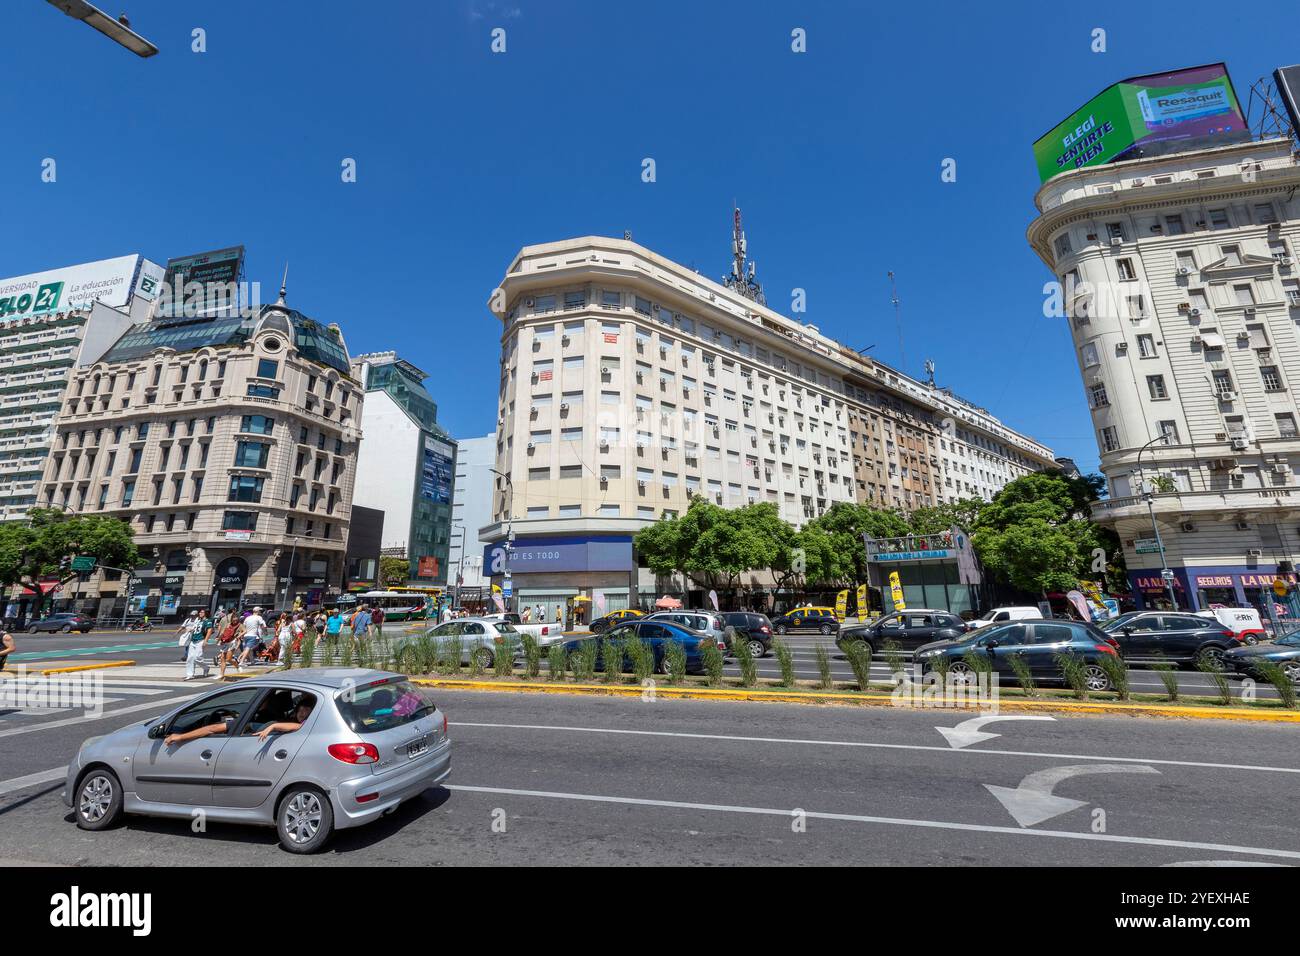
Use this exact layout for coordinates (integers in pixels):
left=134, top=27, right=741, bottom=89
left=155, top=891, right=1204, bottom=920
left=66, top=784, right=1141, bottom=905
left=915, top=620, right=1119, bottom=691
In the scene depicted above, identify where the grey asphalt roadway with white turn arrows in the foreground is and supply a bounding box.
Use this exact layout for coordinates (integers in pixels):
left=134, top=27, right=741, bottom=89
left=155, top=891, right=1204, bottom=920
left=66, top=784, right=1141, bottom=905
left=0, top=682, right=1300, bottom=866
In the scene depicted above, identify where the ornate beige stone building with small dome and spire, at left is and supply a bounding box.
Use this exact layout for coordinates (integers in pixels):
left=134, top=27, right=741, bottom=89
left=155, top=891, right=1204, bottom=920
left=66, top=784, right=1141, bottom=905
left=39, top=299, right=364, bottom=618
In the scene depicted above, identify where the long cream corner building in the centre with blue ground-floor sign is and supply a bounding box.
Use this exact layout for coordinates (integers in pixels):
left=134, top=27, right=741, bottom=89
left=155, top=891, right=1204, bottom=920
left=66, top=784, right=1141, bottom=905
left=480, top=237, right=1054, bottom=610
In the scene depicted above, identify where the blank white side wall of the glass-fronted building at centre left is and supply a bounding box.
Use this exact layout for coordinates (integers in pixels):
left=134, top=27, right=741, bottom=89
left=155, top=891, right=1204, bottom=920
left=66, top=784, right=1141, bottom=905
left=352, top=390, right=421, bottom=548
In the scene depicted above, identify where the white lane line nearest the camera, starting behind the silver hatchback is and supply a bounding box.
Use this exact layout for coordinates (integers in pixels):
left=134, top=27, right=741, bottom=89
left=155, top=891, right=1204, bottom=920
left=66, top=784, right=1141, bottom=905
left=445, top=783, right=1300, bottom=861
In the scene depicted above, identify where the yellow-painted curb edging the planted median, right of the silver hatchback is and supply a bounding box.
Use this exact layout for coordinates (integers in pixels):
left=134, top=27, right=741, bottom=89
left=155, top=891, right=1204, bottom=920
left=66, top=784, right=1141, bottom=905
left=412, top=678, right=1300, bottom=723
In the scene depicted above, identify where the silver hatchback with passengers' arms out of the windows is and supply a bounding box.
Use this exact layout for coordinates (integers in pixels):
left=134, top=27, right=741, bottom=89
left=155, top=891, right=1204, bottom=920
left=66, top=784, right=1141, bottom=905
left=62, top=667, right=451, bottom=853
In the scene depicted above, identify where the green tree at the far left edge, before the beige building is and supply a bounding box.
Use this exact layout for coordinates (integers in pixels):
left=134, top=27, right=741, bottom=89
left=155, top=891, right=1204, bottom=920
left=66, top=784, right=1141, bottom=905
left=0, top=509, right=140, bottom=608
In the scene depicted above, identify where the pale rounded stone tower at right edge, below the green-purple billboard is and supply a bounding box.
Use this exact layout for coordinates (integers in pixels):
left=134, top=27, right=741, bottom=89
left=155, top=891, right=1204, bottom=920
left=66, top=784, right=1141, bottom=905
left=1028, top=139, right=1300, bottom=617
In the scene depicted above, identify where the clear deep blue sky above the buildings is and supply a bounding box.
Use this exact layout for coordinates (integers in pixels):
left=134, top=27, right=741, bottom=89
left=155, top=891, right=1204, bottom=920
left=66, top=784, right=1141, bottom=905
left=0, top=0, right=1300, bottom=476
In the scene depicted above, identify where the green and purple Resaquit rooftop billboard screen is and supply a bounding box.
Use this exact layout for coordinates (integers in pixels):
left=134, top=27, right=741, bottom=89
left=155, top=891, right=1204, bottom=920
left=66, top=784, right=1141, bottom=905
left=1034, top=62, right=1251, bottom=182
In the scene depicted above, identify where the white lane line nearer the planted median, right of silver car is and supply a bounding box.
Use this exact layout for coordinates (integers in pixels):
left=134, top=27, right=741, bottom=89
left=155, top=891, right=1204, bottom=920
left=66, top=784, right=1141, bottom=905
left=447, top=713, right=1300, bottom=774
